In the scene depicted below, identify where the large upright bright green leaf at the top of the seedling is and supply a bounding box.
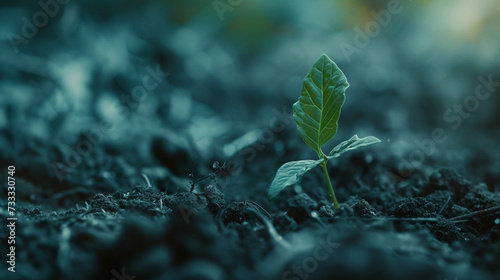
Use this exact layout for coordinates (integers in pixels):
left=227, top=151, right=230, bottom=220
left=293, top=54, right=349, bottom=156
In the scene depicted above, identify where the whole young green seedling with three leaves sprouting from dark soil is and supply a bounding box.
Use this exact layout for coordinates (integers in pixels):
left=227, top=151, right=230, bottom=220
left=268, top=54, right=380, bottom=209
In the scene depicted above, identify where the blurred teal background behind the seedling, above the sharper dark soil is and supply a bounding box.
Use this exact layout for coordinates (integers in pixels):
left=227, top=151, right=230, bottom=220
left=0, top=0, right=500, bottom=207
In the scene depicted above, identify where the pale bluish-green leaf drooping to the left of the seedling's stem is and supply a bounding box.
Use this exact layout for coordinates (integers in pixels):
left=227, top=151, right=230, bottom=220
left=267, top=159, right=323, bottom=201
